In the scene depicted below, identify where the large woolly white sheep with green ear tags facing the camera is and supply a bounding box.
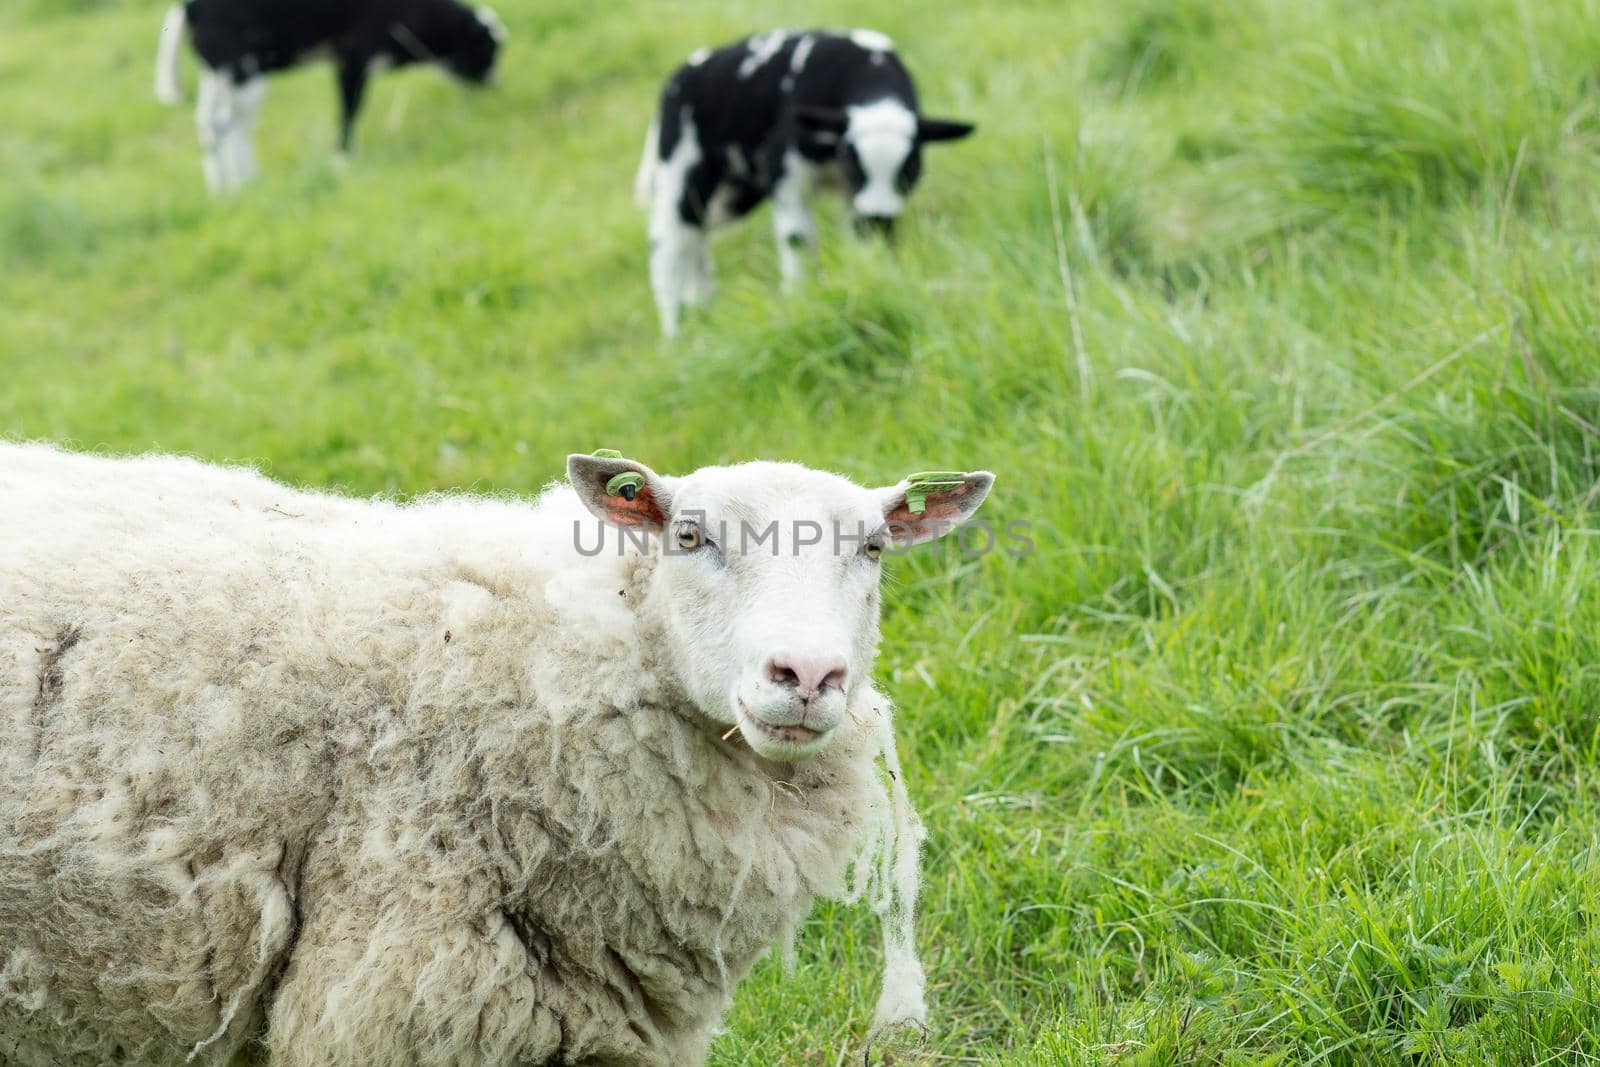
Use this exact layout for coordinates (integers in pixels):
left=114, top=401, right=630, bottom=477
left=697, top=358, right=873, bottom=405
left=0, top=445, right=992, bottom=1067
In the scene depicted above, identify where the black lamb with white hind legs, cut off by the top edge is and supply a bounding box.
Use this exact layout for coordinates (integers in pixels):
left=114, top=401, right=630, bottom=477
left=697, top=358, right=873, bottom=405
left=155, top=0, right=506, bottom=190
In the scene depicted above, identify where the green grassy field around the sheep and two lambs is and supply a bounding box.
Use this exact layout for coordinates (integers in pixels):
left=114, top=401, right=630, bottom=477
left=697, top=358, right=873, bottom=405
left=0, top=0, right=1600, bottom=1067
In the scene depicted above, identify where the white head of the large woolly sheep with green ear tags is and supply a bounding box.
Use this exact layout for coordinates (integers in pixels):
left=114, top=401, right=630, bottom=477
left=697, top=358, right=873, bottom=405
left=566, top=454, right=994, bottom=761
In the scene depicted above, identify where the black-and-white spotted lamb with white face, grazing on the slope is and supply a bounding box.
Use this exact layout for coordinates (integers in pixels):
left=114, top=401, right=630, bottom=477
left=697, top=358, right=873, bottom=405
left=634, top=30, right=973, bottom=336
